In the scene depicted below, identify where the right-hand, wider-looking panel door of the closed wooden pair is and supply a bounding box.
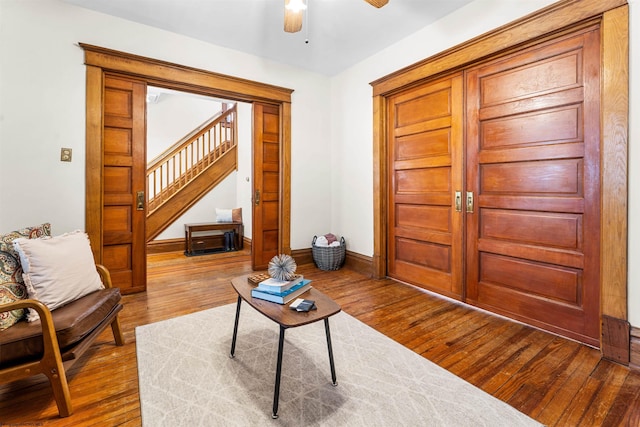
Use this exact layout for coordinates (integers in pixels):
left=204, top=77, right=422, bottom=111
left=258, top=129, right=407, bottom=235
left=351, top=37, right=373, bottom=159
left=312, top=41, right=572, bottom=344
left=466, top=31, right=600, bottom=345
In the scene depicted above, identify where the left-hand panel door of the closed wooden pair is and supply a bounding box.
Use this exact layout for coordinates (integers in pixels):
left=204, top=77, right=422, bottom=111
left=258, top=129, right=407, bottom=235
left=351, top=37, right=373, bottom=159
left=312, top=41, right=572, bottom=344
left=387, top=74, right=463, bottom=299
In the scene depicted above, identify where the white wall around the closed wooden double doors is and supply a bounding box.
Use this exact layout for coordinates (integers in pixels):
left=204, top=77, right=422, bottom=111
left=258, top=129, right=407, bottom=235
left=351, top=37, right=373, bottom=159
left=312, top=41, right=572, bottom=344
left=331, top=0, right=640, bottom=327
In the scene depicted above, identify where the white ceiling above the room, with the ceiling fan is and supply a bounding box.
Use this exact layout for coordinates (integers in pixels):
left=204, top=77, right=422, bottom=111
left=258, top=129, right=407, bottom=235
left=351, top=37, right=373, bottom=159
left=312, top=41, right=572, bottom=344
left=63, top=0, right=472, bottom=75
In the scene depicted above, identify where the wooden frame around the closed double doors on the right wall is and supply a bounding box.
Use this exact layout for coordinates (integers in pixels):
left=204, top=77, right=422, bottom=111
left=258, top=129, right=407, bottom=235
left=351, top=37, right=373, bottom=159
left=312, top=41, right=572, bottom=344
left=371, top=0, right=630, bottom=363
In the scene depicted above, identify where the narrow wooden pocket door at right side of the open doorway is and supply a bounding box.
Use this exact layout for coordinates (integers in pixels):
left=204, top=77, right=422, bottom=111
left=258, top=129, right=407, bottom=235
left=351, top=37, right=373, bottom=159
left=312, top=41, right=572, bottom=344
left=251, top=103, right=280, bottom=270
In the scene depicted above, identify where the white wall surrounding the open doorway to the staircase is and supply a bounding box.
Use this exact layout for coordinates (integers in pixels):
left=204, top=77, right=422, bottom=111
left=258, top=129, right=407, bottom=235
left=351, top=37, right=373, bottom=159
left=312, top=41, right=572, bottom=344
left=0, top=0, right=332, bottom=249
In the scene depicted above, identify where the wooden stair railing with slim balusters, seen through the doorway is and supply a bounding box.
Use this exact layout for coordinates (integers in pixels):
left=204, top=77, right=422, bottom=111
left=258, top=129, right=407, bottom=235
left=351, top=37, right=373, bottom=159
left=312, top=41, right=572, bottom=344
left=147, top=104, right=237, bottom=215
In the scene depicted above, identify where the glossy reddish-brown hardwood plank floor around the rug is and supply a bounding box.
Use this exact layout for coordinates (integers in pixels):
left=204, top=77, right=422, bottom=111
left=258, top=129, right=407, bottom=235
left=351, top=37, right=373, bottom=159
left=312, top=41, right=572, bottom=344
left=0, top=250, right=640, bottom=426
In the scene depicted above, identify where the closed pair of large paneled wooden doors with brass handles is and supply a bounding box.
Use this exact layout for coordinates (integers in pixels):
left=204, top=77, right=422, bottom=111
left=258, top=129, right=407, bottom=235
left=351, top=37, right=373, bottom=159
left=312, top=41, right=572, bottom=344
left=387, top=27, right=600, bottom=346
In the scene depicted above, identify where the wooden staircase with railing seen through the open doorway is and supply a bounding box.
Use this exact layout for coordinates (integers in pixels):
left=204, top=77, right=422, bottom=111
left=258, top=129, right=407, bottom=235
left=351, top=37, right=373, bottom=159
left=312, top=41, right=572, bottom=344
left=146, top=104, right=238, bottom=242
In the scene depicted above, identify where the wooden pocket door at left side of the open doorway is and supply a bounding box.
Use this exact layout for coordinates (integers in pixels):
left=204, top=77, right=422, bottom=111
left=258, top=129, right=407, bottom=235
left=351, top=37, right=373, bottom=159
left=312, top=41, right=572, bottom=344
left=101, top=76, right=147, bottom=293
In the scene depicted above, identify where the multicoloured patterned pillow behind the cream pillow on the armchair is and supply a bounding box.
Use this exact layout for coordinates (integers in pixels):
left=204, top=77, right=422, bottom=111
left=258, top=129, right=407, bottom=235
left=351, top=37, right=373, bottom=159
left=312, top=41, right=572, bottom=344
left=0, top=223, right=51, bottom=331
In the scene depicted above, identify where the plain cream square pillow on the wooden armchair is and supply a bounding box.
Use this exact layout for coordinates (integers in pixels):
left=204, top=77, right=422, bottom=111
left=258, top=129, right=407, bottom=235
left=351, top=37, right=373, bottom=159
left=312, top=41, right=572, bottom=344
left=13, top=231, right=104, bottom=322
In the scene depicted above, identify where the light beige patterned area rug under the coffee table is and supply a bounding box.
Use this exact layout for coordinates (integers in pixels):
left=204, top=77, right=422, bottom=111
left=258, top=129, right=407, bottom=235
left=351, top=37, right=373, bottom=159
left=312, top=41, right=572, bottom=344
left=136, top=304, right=539, bottom=427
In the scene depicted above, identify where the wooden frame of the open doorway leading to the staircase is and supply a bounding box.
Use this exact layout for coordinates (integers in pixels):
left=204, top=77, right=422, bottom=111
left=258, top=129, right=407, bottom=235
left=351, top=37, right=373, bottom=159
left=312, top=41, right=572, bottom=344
left=79, top=43, right=293, bottom=268
